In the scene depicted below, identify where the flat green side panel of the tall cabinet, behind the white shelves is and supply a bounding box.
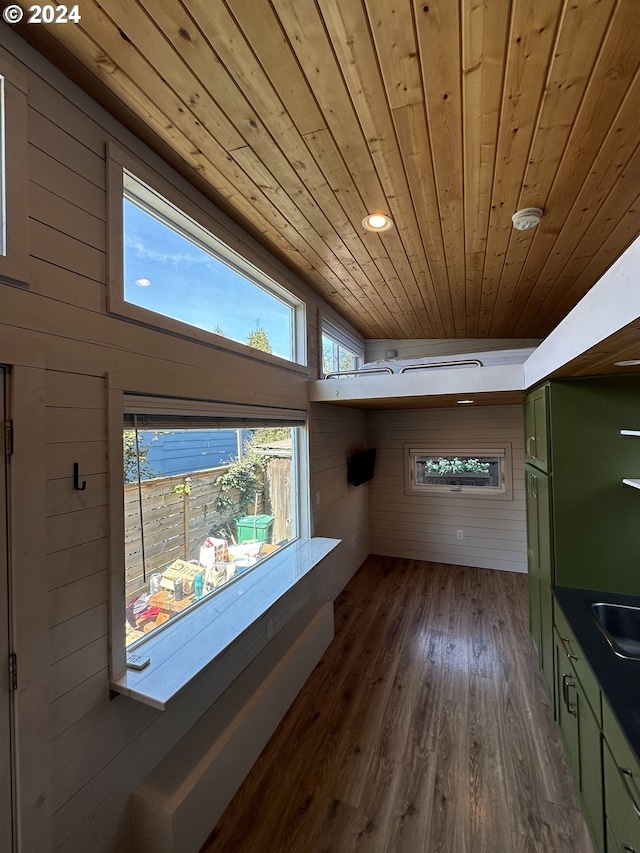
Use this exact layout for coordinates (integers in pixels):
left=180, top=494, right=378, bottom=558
left=549, top=374, right=640, bottom=595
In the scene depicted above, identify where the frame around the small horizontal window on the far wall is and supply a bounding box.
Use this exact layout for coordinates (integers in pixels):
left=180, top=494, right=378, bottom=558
left=404, top=441, right=513, bottom=501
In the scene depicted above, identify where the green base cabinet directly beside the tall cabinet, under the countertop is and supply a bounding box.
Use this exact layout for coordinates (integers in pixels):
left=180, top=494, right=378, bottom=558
left=554, top=627, right=604, bottom=853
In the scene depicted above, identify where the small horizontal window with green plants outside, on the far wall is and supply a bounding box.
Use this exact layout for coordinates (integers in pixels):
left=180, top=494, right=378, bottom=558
left=406, top=444, right=512, bottom=500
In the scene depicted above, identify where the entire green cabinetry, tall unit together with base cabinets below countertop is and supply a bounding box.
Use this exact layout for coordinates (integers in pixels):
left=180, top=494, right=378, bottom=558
left=524, top=374, right=640, bottom=853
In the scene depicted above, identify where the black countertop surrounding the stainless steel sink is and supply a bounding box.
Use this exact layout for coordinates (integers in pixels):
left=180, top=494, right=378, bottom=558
left=553, top=586, right=640, bottom=762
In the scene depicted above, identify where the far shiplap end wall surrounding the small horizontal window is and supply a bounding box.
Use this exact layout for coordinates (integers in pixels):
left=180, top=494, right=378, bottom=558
left=369, top=406, right=527, bottom=572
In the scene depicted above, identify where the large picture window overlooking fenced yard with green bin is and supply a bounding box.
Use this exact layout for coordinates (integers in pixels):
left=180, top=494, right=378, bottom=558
left=122, top=404, right=304, bottom=650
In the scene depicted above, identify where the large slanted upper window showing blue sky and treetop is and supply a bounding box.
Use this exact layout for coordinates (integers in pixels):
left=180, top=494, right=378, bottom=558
left=112, top=169, right=304, bottom=362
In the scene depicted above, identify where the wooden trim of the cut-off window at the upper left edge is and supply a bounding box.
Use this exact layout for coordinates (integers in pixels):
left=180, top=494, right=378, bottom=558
left=0, top=49, right=29, bottom=285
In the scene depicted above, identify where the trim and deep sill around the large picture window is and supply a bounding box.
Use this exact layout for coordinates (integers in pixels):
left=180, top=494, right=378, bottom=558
left=108, top=386, right=316, bottom=708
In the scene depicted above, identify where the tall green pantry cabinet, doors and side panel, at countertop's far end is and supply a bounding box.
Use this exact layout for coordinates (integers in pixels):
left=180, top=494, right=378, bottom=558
left=524, top=375, right=640, bottom=697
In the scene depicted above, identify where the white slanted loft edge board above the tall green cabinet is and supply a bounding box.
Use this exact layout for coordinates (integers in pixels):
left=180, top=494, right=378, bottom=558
left=524, top=237, right=640, bottom=388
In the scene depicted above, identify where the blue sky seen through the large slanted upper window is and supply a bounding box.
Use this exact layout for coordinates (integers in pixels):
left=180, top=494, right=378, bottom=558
left=124, top=199, right=291, bottom=358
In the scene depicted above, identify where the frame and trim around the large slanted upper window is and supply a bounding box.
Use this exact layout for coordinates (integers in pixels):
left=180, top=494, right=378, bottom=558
left=107, top=142, right=308, bottom=375
